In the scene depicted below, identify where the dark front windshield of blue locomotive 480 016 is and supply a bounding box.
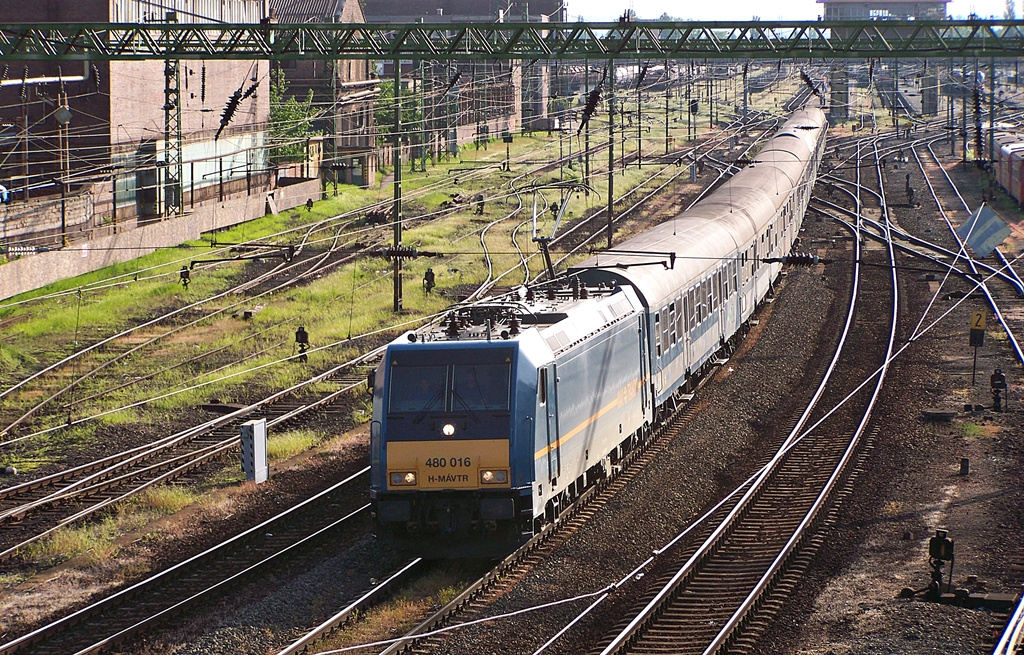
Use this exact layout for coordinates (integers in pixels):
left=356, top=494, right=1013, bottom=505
left=388, top=363, right=512, bottom=413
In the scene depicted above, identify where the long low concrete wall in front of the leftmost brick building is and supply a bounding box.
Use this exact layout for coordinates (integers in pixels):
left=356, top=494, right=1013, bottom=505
left=0, top=180, right=321, bottom=299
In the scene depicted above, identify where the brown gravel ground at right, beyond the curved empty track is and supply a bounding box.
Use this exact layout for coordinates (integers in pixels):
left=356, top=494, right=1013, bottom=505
left=758, top=130, right=1024, bottom=655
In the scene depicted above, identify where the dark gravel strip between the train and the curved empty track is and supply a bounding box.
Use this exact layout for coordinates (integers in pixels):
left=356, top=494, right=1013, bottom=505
left=415, top=237, right=845, bottom=653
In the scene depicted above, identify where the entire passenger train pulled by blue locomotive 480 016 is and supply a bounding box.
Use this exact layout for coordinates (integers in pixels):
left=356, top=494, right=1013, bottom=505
left=370, top=108, right=826, bottom=557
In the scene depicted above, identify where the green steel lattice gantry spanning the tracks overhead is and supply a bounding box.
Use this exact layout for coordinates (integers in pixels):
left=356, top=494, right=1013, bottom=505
left=0, top=19, right=1024, bottom=60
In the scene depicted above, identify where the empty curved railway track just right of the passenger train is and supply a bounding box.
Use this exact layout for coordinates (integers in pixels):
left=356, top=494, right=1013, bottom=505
left=569, top=138, right=897, bottom=654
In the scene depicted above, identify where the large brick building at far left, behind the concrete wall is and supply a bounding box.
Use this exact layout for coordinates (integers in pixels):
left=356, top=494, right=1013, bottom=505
left=0, top=0, right=273, bottom=238
